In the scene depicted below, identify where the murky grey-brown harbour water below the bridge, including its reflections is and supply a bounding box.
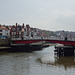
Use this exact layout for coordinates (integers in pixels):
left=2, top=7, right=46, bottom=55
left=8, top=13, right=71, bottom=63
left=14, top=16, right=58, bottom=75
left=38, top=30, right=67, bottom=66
left=0, top=46, right=75, bottom=75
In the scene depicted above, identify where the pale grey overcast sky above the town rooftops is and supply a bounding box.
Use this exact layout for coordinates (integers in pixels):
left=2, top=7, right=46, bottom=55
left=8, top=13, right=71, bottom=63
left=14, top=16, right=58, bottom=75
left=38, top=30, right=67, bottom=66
left=0, top=0, right=75, bottom=31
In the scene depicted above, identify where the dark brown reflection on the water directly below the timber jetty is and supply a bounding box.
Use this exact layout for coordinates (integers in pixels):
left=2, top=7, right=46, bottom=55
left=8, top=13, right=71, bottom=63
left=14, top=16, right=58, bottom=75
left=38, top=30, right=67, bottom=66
left=54, top=57, right=75, bottom=69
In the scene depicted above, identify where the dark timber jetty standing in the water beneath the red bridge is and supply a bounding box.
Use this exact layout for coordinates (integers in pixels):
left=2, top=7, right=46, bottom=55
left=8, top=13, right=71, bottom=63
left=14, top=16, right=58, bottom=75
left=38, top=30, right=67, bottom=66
left=54, top=45, right=74, bottom=56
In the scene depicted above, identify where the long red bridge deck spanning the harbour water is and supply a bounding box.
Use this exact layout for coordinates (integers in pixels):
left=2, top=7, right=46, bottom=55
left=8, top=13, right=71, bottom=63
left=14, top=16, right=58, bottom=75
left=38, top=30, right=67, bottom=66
left=11, top=39, right=75, bottom=45
